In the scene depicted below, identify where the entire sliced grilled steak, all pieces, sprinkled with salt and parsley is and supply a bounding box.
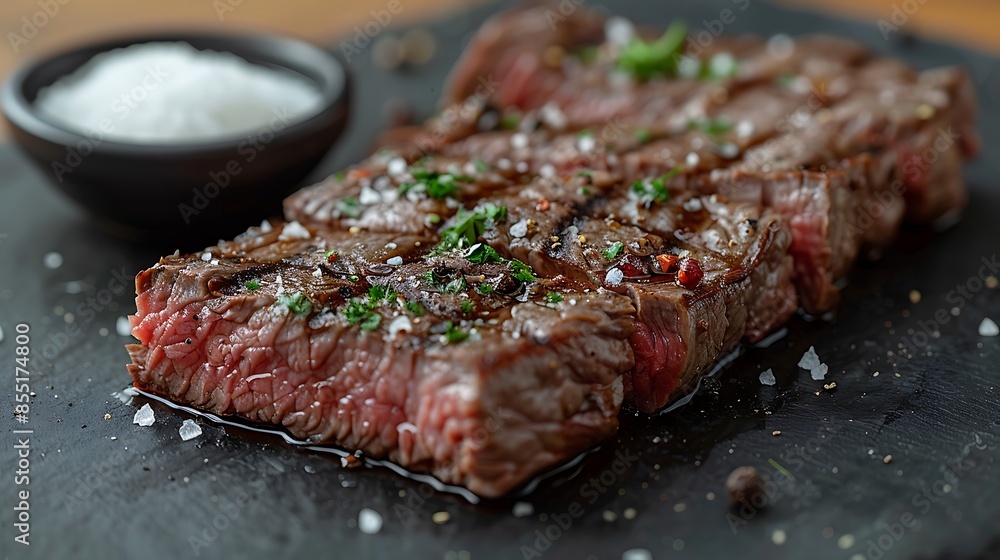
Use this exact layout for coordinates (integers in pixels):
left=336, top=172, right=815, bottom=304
left=128, top=8, right=977, bottom=497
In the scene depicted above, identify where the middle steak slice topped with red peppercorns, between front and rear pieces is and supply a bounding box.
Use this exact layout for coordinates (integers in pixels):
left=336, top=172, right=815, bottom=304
left=288, top=158, right=797, bottom=412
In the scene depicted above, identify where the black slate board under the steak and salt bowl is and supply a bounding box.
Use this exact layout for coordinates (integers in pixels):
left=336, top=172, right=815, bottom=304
left=0, top=0, right=1000, bottom=560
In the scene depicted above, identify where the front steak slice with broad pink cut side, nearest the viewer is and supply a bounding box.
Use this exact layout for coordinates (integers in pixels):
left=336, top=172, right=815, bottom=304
left=128, top=224, right=634, bottom=497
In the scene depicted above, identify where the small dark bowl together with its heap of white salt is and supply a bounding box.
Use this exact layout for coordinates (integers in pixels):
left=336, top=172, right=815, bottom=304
left=0, top=33, right=350, bottom=241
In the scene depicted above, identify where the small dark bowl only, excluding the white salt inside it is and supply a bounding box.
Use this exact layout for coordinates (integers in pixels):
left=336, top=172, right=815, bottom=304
left=0, top=33, right=350, bottom=241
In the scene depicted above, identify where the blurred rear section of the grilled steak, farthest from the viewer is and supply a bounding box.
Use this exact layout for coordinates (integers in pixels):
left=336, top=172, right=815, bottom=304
left=422, top=7, right=978, bottom=313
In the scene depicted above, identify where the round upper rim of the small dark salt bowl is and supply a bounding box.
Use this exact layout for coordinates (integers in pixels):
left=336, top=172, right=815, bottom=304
left=0, top=29, right=350, bottom=159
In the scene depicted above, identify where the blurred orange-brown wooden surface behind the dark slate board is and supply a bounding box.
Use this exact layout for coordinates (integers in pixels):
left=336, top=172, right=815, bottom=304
left=0, top=0, right=1000, bottom=82
